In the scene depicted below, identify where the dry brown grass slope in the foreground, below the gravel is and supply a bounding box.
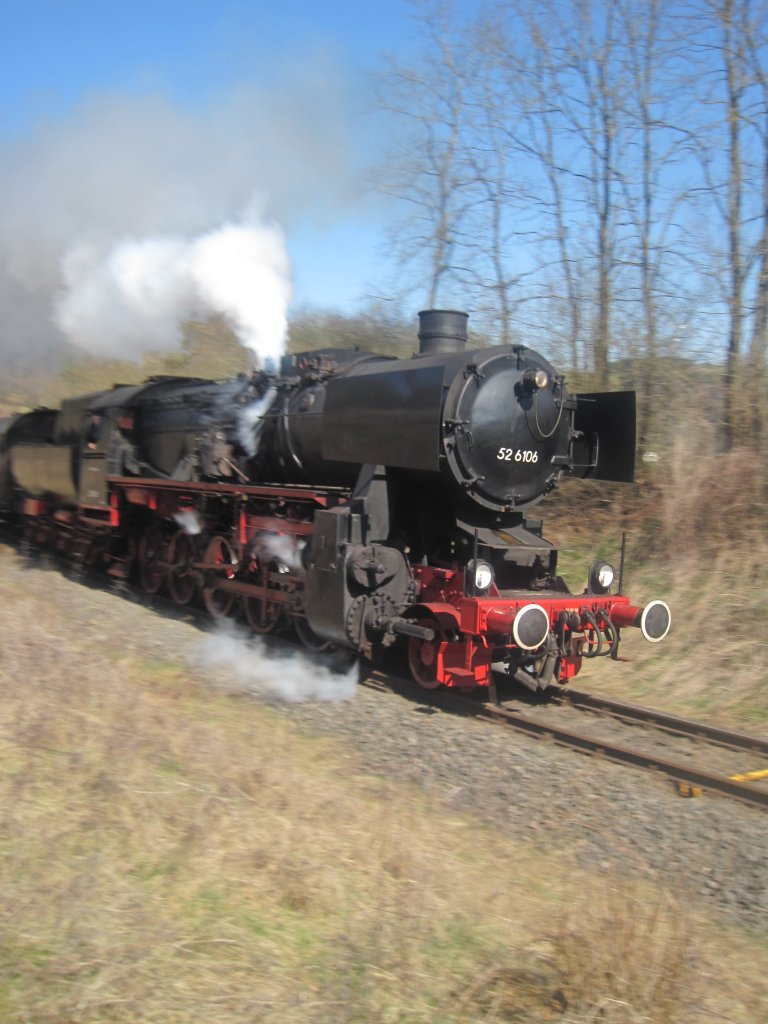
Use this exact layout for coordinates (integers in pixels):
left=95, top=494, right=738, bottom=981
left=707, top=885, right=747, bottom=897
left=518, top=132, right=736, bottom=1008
left=0, top=551, right=758, bottom=1024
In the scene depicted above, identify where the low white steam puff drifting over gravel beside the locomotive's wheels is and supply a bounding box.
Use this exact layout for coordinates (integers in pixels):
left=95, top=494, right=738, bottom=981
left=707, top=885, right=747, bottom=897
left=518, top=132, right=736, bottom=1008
left=193, top=621, right=357, bottom=703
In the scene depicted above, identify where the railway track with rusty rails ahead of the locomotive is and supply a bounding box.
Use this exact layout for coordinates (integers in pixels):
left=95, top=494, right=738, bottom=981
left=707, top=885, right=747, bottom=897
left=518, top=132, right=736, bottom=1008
left=362, top=672, right=768, bottom=810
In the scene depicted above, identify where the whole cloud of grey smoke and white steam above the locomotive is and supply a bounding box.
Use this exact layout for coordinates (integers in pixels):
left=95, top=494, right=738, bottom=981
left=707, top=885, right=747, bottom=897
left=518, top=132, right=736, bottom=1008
left=0, top=69, right=356, bottom=371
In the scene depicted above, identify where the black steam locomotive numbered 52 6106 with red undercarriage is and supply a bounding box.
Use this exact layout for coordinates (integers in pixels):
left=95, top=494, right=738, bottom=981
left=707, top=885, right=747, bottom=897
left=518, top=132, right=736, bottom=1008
left=0, top=309, right=670, bottom=690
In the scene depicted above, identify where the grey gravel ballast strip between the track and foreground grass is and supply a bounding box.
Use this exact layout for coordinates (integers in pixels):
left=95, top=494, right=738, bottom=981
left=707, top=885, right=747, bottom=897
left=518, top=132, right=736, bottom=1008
left=3, top=549, right=768, bottom=936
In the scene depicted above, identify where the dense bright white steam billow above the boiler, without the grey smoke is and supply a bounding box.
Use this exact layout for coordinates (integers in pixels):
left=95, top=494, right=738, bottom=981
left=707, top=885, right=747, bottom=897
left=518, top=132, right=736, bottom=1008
left=53, top=212, right=291, bottom=367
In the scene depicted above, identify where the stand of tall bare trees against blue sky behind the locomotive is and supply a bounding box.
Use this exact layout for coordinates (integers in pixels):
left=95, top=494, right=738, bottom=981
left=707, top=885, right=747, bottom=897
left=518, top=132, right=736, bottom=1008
left=376, top=0, right=768, bottom=460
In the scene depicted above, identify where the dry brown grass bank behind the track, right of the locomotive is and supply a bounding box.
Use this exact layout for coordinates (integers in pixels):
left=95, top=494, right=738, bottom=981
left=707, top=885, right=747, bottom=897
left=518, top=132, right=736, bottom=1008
left=547, top=423, right=768, bottom=728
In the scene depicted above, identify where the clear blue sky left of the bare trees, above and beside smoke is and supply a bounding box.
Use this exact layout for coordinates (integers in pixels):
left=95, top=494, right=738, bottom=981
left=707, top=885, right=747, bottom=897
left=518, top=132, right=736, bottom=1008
left=0, top=0, right=428, bottom=308
